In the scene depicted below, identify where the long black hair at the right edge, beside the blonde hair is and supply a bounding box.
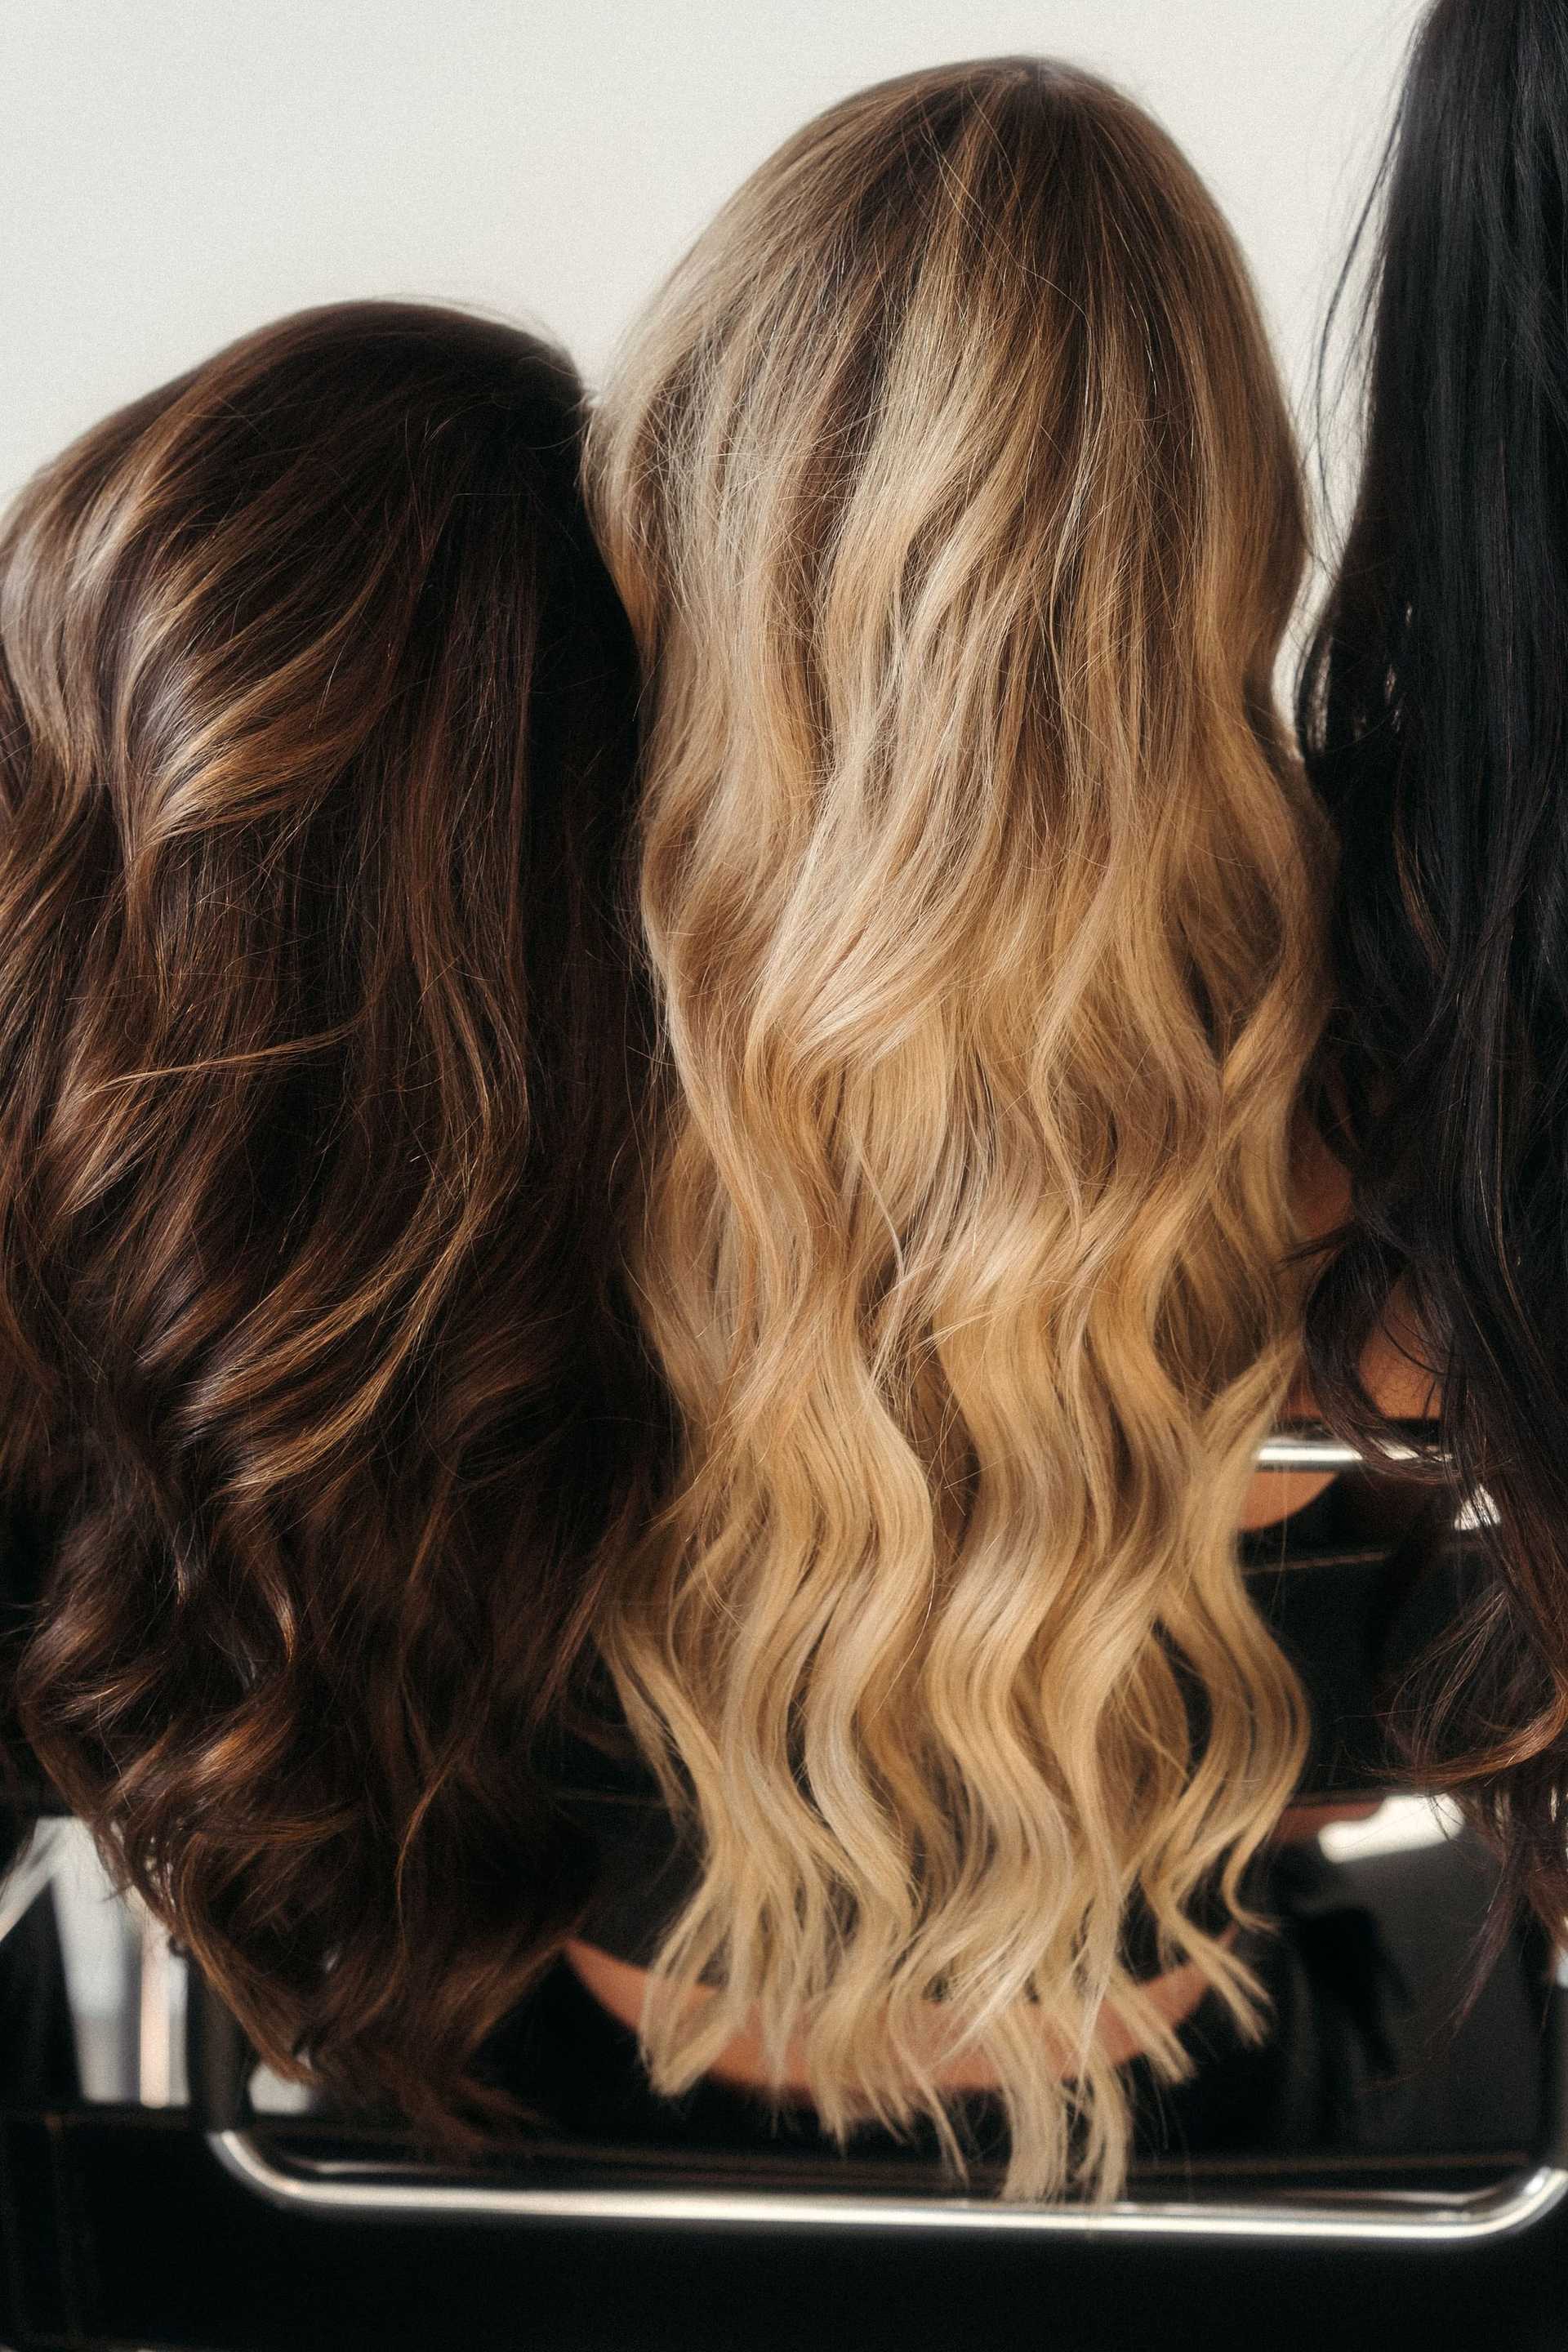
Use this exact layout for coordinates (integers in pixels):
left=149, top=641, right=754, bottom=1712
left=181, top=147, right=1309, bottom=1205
left=1298, top=0, right=1568, bottom=1931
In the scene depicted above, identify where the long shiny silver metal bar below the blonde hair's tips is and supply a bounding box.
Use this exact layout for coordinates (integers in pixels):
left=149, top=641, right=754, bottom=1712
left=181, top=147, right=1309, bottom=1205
left=207, top=2131, right=1568, bottom=2246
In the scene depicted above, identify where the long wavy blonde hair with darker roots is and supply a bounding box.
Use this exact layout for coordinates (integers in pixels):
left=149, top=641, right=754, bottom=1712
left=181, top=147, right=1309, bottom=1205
left=590, top=59, right=1321, bottom=2194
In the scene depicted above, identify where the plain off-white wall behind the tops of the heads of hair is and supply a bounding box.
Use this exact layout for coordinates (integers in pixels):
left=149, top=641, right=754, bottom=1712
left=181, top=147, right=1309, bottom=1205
left=0, top=0, right=1420, bottom=497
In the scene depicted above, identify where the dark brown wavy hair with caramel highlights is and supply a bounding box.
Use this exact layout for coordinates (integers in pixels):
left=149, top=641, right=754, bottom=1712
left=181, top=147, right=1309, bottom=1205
left=0, top=304, right=658, bottom=2136
